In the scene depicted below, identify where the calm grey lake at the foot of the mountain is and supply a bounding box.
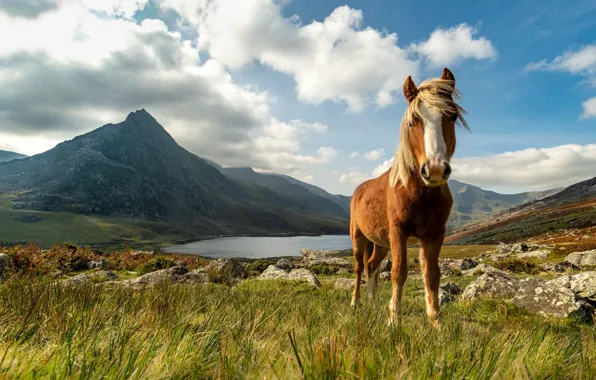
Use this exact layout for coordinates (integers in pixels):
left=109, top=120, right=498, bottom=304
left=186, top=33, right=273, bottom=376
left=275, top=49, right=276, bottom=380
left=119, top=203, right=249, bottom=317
left=164, top=235, right=352, bottom=259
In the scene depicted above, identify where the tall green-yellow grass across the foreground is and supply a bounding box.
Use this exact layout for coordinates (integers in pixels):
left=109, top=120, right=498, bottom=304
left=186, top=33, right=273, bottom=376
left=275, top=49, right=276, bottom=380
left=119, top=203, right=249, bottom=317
left=0, top=278, right=596, bottom=379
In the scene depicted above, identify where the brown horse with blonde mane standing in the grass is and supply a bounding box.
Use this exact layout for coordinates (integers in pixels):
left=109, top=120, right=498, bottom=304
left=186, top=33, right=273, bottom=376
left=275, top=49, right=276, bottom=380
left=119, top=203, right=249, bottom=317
left=350, top=68, right=468, bottom=324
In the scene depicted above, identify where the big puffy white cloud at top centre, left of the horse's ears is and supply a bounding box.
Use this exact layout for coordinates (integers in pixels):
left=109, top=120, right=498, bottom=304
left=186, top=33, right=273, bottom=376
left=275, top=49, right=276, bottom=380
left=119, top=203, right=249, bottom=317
left=160, top=0, right=418, bottom=111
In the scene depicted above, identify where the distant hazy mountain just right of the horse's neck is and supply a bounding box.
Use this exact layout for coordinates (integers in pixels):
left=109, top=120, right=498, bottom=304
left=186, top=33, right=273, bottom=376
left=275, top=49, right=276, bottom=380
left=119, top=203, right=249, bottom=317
left=449, top=180, right=561, bottom=228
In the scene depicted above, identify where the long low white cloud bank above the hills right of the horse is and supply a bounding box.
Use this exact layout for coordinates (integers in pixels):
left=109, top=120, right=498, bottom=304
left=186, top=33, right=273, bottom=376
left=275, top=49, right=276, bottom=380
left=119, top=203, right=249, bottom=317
left=451, top=144, right=596, bottom=191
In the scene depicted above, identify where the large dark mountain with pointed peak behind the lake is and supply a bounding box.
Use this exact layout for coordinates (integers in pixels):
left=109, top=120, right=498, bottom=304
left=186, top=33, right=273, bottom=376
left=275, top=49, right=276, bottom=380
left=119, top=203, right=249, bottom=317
left=0, top=109, right=348, bottom=237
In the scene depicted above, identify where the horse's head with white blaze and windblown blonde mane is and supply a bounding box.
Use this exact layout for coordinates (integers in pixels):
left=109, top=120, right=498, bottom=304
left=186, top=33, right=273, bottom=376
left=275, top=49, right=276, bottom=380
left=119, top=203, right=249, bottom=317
left=393, top=68, right=467, bottom=187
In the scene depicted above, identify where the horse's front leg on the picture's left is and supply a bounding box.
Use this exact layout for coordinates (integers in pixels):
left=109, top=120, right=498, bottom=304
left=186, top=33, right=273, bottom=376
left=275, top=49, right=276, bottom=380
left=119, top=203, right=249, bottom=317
left=389, top=227, right=408, bottom=324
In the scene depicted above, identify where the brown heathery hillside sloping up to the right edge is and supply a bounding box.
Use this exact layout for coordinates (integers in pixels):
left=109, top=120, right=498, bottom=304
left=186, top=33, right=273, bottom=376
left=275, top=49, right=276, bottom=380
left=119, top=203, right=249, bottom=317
left=446, top=177, right=596, bottom=244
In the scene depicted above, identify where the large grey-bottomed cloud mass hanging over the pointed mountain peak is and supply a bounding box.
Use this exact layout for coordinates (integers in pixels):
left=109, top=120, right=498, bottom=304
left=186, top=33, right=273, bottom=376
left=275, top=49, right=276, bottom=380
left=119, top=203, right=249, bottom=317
left=0, top=0, right=337, bottom=174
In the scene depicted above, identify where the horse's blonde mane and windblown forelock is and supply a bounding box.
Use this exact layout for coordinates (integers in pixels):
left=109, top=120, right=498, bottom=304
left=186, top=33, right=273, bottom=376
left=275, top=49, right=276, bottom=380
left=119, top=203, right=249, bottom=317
left=389, top=78, right=470, bottom=187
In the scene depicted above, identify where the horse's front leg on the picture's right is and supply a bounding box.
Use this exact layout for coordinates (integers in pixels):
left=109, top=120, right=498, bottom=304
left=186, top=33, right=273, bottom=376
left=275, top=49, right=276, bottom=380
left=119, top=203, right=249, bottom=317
left=420, top=230, right=445, bottom=326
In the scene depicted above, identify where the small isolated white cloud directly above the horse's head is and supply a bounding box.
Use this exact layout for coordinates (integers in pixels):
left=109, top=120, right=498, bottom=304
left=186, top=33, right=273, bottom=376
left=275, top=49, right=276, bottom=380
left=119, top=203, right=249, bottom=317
left=410, top=24, right=497, bottom=67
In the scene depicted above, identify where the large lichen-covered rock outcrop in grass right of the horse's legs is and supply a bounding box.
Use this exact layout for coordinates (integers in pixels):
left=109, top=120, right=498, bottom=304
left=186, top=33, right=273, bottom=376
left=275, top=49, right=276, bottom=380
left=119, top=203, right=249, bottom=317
left=462, top=271, right=594, bottom=320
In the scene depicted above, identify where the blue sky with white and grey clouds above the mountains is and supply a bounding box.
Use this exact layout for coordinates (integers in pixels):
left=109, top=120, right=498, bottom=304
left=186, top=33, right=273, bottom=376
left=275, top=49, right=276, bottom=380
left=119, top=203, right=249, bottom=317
left=0, top=0, right=596, bottom=195
